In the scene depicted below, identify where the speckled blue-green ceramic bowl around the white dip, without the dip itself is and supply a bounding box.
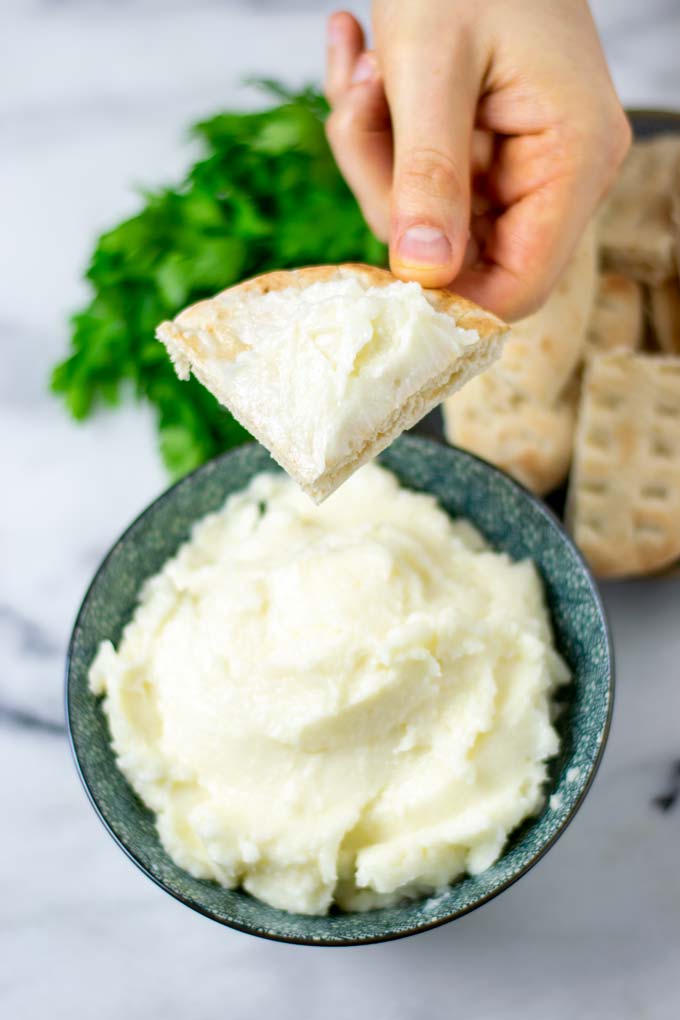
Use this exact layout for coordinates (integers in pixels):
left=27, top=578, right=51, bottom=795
left=66, top=437, right=613, bottom=946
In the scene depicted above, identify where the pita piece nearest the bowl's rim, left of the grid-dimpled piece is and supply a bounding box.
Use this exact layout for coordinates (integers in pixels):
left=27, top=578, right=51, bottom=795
left=442, top=369, right=578, bottom=496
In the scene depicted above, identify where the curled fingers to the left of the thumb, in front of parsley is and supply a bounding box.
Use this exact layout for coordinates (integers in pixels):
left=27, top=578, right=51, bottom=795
left=326, top=14, right=393, bottom=241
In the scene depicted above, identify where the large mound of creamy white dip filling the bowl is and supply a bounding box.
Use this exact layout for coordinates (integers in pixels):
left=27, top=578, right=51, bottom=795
left=90, top=464, right=568, bottom=914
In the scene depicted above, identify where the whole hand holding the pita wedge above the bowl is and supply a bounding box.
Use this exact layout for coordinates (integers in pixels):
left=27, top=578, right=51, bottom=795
left=326, top=0, right=630, bottom=318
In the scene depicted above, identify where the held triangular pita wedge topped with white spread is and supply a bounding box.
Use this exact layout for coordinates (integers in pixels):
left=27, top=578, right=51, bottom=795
left=157, top=264, right=507, bottom=502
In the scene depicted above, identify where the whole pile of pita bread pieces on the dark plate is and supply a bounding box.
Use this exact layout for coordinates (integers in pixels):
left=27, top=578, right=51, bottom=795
left=443, top=136, right=680, bottom=577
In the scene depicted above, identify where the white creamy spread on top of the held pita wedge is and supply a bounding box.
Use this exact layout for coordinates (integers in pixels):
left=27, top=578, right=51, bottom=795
left=180, top=276, right=479, bottom=481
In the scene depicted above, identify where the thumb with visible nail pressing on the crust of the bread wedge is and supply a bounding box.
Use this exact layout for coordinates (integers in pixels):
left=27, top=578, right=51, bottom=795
left=376, top=4, right=480, bottom=287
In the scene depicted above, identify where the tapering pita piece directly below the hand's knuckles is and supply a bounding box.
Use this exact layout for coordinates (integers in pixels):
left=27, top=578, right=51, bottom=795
left=493, top=224, right=597, bottom=407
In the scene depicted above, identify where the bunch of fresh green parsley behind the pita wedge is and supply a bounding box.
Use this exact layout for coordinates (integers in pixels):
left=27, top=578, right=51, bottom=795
left=51, top=82, right=385, bottom=477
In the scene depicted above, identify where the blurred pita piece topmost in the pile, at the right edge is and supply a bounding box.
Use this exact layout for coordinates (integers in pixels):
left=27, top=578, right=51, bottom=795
left=598, top=135, right=680, bottom=287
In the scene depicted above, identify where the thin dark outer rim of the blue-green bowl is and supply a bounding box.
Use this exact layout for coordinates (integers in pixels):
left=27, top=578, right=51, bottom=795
left=64, top=435, right=616, bottom=949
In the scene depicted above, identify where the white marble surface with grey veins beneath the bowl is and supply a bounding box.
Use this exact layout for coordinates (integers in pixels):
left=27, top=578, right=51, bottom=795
left=0, top=0, right=680, bottom=1020
